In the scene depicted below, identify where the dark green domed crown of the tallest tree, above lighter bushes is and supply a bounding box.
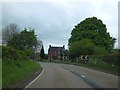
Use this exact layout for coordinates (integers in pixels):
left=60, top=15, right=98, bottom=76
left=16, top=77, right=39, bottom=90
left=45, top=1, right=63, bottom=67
left=68, top=17, right=116, bottom=51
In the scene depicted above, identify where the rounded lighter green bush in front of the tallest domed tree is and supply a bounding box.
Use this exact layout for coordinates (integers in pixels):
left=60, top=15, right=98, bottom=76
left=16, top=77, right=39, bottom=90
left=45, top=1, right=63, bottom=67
left=69, top=39, right=95, bottom=59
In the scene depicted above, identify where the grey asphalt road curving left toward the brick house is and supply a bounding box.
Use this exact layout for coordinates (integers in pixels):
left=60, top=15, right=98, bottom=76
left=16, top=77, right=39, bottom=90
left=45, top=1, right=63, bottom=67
left=26, top=63, right=118, bottom=88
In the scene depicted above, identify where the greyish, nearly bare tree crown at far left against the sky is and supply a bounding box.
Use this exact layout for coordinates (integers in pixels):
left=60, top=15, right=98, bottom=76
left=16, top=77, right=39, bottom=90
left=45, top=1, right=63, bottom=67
left=2, top=24, right=20, bottom=44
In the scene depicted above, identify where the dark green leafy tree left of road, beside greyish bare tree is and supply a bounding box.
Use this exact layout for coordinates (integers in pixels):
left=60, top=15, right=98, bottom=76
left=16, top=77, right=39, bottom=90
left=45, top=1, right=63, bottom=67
left=7, top=28, right=37, bottom=58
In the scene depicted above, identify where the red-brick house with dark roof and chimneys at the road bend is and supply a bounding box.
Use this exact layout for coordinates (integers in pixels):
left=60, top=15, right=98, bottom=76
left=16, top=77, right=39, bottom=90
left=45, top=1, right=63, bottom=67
left=48, top=45, right=65, bottom=60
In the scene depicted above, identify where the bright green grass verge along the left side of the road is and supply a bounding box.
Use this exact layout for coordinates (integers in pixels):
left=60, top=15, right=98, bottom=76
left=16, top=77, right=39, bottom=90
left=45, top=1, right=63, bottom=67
left=2, top=60, right=41, bottom=88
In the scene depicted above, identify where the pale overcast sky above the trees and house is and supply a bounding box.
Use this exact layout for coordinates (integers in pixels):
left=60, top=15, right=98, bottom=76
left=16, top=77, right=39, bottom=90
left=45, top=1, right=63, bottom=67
left=0, top=0, right=119, bottom=53
